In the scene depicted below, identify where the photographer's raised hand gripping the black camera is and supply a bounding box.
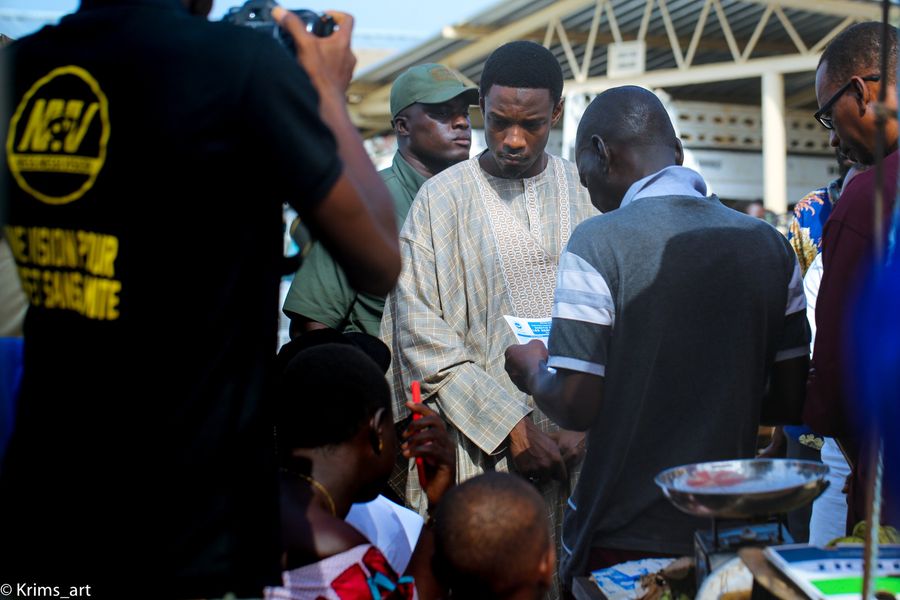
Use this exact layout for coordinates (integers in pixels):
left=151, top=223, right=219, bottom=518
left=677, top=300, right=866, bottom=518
left=272, top=6, right=356, bottom=95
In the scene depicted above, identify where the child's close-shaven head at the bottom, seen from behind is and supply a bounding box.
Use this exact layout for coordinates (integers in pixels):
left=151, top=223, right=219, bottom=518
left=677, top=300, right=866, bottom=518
left=434, top=473, right=556, bottom=600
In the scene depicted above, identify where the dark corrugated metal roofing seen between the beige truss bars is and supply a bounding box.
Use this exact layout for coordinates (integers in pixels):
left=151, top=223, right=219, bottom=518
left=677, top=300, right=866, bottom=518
left=350, top=0, right=878, bottom=135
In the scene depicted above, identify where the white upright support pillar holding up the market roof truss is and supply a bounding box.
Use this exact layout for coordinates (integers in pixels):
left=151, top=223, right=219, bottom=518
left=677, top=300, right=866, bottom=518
left=762, top=71, right=787, bottom=215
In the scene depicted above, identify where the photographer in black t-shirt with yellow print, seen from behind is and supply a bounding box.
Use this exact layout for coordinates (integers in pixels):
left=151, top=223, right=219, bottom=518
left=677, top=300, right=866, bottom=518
left=0, top=0, right=400, bottom=597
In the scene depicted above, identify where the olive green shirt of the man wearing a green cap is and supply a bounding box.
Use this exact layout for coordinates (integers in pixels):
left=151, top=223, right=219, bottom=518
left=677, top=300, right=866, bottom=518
left=283, top=152, right=428, bottom=336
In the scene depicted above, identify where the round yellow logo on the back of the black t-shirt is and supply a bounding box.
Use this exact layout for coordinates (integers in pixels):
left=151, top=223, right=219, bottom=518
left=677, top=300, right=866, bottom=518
left=6, top=65, right=109, bottom=204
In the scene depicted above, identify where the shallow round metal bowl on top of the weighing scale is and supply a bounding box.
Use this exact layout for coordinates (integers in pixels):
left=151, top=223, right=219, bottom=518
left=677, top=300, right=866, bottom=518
left=654, top=459, right=828, bottom=519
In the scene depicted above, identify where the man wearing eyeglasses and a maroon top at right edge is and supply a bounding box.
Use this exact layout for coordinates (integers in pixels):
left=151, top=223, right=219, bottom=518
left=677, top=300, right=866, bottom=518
left=804, top=22, right=898, bottom=528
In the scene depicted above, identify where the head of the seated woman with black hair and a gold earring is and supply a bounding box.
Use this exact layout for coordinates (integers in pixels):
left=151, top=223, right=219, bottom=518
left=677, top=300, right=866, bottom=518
left=276, top=343, right=397, bottom=500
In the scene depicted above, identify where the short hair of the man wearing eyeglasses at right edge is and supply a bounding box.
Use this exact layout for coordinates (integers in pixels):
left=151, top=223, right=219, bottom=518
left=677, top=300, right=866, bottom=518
left=817, top=21, right=897, bottom=85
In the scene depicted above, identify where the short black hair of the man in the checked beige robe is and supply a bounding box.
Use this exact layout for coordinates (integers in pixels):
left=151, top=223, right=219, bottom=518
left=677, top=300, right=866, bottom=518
left=480, top=41, right=563, bottom=106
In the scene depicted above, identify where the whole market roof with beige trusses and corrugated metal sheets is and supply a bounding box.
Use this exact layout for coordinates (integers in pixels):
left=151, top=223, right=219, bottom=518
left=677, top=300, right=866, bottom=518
left=348, top=0, right=881, bottom=134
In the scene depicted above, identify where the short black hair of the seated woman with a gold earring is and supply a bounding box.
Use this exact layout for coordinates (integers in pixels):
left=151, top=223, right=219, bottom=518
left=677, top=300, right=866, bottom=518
left=275, top=344, right=391, bottom=460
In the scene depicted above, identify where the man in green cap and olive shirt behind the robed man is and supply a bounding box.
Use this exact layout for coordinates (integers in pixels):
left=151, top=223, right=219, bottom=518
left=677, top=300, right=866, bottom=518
left=284, top=64, right=478, bottom=338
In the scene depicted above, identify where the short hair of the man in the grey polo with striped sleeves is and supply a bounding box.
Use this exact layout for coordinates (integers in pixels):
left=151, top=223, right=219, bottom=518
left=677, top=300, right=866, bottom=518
left=576, top=85, right=676, bottom=147
